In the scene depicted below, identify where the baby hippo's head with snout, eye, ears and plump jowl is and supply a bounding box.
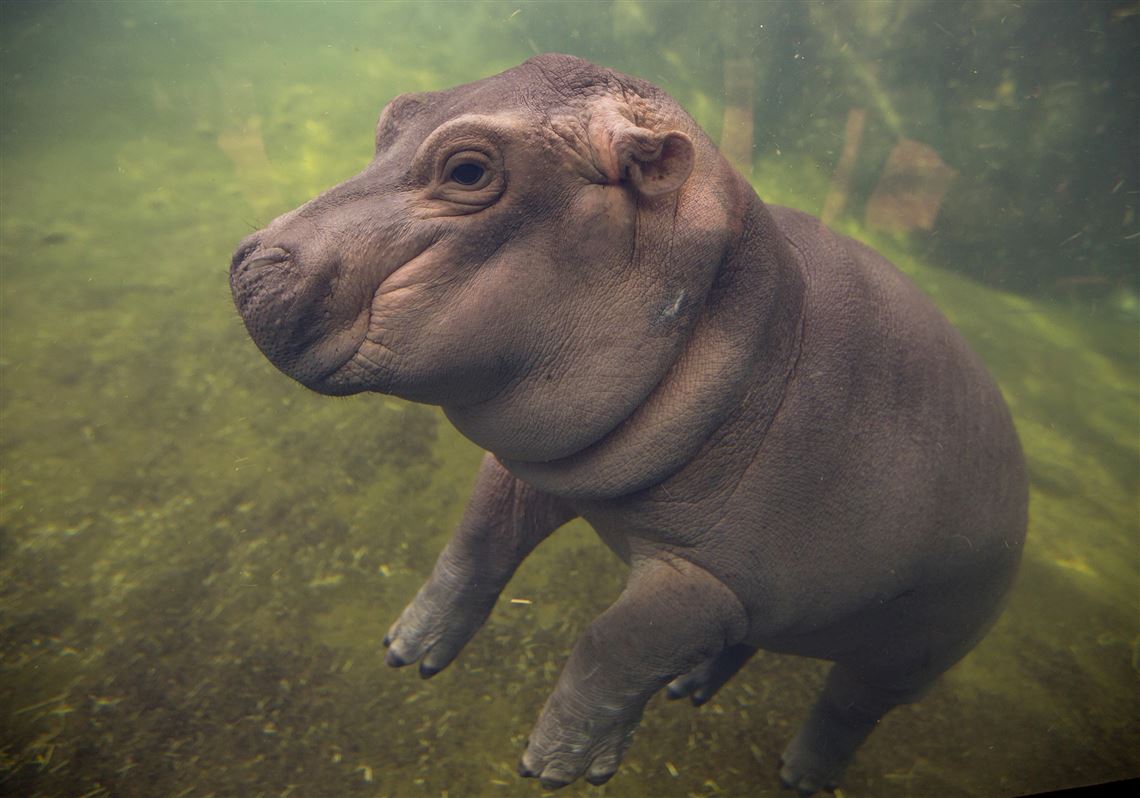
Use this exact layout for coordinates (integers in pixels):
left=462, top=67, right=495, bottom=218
left=230, top=55, right=740, bottom=462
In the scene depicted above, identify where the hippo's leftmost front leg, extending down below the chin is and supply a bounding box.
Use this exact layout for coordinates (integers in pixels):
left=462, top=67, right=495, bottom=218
left=384, top=455, right=575, bottom=678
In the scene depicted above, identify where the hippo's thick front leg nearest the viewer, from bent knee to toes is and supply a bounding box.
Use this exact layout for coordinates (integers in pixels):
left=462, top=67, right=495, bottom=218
left=519, top=555, right=748, bottom=789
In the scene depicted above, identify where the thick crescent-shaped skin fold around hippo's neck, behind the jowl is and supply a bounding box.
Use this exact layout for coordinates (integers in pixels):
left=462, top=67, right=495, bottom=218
left=499, top=179, right=804, bottom=500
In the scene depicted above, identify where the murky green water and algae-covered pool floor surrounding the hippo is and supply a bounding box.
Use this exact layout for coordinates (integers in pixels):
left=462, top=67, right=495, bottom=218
left=0, top=0, right=1140, bottom=798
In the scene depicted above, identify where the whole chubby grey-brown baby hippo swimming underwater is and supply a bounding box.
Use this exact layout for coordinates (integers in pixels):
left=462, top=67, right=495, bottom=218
left=230, top=55, right=1026, bottom=795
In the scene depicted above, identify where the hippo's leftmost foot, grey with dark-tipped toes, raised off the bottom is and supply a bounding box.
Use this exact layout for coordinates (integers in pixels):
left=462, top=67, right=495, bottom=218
left=384, top=570, right=496, bottom=678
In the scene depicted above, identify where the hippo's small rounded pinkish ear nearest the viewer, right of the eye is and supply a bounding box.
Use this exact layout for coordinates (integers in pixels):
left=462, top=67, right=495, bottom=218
left=589, top=105, right=695, bottom=197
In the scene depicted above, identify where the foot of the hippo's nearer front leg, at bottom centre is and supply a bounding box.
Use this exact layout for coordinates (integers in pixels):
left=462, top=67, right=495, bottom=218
left=519, top=697, right=641, bottom=790
